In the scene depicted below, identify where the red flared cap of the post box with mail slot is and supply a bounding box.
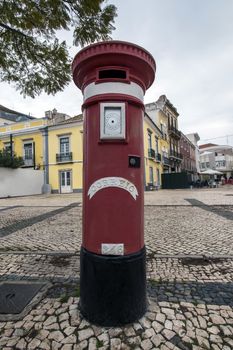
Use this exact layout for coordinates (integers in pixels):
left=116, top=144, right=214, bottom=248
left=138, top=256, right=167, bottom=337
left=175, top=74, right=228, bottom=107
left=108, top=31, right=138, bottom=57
left=72, top=40, right=156, bottom=92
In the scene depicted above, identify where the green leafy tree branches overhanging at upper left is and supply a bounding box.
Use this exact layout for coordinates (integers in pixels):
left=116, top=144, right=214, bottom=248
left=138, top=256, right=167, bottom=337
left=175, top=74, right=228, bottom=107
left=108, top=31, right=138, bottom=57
left=0, top=0, right=116, bottom=97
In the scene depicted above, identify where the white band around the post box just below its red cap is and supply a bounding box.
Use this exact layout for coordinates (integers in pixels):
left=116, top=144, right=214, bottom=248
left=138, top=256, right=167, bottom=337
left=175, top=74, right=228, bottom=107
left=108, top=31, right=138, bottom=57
left=83, top=82, right=144, bottom=102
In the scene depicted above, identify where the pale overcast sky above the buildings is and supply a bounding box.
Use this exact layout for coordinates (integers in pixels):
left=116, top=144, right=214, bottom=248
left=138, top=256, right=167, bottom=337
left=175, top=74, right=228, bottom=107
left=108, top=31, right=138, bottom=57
left=0, top=0, right=233, bottom=145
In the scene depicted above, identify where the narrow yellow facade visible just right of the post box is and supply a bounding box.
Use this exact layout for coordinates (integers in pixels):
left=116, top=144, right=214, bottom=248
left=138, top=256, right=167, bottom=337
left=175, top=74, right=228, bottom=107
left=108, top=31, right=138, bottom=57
left=143, top=113, right=163, bottom=190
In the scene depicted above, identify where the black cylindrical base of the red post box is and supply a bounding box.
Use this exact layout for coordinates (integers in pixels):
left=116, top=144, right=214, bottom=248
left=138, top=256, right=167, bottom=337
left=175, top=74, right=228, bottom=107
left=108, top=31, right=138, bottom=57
left=79, top=247, right=147, bottom=327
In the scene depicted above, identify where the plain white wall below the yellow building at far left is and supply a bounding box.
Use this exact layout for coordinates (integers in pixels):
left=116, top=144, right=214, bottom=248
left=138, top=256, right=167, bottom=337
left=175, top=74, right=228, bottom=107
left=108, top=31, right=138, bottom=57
left=0, top=167, right=44, bottom=197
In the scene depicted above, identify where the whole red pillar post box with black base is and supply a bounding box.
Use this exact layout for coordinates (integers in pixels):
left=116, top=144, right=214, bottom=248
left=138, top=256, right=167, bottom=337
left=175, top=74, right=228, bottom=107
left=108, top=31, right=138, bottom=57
left=72, top=41, right=155, bottom=326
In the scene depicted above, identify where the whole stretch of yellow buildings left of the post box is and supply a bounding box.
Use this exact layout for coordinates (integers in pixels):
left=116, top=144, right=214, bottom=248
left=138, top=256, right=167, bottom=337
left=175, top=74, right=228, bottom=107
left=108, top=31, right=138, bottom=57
left=0, top=106, right=83, bottom=193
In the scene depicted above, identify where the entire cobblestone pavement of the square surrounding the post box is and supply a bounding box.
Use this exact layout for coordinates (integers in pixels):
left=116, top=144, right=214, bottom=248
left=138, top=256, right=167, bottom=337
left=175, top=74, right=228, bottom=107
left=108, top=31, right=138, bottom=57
left=0, top=188, right=233, bottom=350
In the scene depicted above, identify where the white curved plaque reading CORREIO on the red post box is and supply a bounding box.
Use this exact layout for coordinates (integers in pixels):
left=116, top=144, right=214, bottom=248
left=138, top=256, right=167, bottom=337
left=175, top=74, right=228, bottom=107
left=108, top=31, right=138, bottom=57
left=87, top=177, right=138, bottom=200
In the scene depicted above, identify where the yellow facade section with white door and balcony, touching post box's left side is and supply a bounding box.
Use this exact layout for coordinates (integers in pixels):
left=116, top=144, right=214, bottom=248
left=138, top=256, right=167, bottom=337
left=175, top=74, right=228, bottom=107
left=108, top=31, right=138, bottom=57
left=45, top=116, right=83, bottom=193
